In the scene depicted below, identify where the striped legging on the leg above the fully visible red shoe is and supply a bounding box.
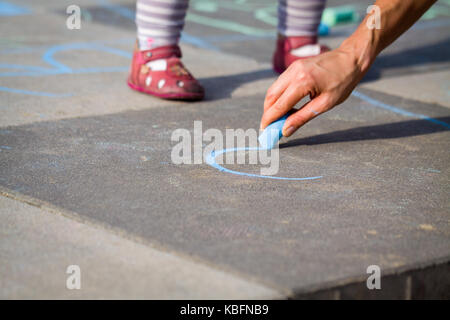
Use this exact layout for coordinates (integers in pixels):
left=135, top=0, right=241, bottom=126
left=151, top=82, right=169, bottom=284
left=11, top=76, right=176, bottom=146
left=136, top=0, right=189, bottom=50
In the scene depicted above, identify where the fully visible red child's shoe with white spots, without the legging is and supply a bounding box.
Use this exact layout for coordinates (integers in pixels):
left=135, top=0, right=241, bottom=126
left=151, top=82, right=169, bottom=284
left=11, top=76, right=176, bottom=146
left=128, top=45, right=205, bottom=100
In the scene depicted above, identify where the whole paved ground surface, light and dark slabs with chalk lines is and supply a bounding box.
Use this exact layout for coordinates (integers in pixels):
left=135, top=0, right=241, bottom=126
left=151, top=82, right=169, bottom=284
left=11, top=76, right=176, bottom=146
left=0, top=1, right=450, bottom=298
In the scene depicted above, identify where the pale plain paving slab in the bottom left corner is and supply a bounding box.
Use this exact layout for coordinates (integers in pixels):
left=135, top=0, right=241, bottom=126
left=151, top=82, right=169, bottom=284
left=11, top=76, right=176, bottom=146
left=0, top=196, right=282, bottom=299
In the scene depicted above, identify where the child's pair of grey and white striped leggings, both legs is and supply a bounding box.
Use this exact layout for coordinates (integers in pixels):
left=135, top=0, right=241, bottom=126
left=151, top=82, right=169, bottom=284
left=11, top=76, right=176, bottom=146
left=136, top=0, right=326, bottom=50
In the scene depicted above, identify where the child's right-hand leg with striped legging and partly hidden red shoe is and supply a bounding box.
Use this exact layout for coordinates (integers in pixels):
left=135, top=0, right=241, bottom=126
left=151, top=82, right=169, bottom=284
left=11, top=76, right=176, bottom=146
left=273, top=0, right=329, bottom=73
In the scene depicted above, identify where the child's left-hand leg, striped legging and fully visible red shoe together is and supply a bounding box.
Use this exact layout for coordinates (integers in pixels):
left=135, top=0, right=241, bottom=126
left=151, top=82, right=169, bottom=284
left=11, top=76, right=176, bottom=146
left=128, top=0, right=204, bottom=100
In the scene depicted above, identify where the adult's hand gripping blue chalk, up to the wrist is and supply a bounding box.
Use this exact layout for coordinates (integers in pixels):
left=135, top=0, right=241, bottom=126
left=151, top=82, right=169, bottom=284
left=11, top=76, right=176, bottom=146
left=261, top=48, right=363, bottom=137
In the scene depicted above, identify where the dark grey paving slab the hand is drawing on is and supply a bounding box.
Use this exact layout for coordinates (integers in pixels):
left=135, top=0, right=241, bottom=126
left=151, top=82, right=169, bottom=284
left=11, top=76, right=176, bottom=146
left=0, top=87, right=450, bottom=291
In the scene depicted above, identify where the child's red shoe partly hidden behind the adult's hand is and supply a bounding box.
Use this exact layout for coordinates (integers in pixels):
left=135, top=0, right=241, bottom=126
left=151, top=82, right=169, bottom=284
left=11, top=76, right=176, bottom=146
left=273, top=35, right=330, bottom=73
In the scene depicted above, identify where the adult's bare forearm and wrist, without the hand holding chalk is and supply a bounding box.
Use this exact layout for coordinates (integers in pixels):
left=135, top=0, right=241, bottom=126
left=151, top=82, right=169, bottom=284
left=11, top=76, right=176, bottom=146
left=339, top=0, right=436, bottom=74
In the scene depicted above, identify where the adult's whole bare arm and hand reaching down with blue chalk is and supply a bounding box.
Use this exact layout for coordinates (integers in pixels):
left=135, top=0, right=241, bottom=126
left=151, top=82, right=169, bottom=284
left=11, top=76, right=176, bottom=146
left=261, top=0, right=436, bottom=137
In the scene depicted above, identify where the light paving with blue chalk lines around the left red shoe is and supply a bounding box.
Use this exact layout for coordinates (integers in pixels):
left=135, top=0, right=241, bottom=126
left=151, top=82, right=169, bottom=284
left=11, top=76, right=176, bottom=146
left=0, top=1, right=266, bottom=126
